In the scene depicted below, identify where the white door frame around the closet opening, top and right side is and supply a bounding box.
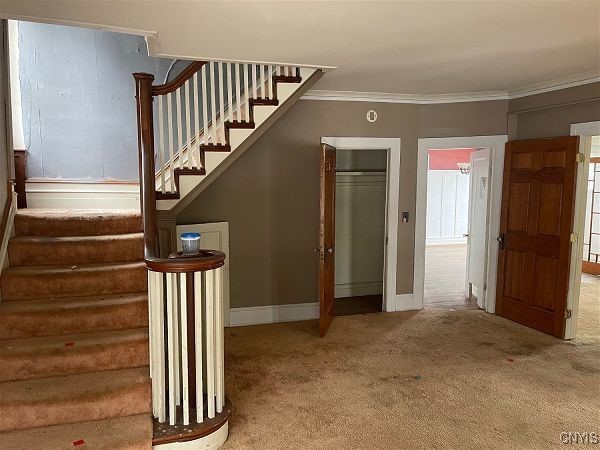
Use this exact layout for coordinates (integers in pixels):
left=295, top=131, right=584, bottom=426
left=321, top=136, right=401, bottom=312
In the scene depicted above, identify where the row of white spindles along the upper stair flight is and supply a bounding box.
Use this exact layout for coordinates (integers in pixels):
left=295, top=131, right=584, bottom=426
left=154, top=62, right=295, bottom=194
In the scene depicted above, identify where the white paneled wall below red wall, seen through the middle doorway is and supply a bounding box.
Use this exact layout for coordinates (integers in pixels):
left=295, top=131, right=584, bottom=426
left=426, top=170, right=470, bottom=244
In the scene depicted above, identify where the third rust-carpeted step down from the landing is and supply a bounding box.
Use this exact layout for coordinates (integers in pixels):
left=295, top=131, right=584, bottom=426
left=0, top=261, right=148, bottom=301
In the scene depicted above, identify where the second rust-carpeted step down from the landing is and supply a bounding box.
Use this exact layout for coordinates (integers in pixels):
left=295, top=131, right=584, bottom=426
left=8, top=233, right=144, bottom=267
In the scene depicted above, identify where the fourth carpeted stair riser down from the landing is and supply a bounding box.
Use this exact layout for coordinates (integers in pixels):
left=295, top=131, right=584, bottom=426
left=0, top=300, right=148, bottom=339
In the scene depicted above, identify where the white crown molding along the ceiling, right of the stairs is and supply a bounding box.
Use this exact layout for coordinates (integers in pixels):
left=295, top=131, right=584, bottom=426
left=300, top=70, right=600, bottom=105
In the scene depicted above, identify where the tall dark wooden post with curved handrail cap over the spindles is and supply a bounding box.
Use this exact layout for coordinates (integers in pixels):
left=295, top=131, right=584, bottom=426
left=133, top=71, right=225, bottom=273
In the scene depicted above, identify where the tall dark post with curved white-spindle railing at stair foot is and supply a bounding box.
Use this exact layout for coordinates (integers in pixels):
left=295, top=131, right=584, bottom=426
left=134, top=69, right=230, bottom=448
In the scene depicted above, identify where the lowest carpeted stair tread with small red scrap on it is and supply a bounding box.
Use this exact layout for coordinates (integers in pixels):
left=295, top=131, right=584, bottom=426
left=0, top=414, right=152, bottom=450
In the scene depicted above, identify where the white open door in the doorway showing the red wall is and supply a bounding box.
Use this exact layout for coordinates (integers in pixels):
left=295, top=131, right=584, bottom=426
left=467, top=148, right=491, bottom=309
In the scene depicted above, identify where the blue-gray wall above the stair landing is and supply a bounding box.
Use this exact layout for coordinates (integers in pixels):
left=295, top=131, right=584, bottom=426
left=19, top=22, right=171, bottom=181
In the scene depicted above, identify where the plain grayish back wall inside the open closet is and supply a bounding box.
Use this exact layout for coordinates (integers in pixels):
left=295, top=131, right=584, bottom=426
left=335, top=172, right=386, bottom=298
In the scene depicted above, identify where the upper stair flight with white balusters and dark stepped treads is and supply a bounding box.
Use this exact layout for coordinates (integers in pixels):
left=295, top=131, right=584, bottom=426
left=134, top=61, right=322, bottom=213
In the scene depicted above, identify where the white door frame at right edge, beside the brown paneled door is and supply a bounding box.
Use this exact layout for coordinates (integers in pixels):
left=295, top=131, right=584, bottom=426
left=565, top=121, right=600, bottom=339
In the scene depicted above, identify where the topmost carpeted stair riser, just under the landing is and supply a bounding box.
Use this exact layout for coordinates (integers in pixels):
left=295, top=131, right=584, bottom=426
left=15, top=214, right=142, bottom=237
